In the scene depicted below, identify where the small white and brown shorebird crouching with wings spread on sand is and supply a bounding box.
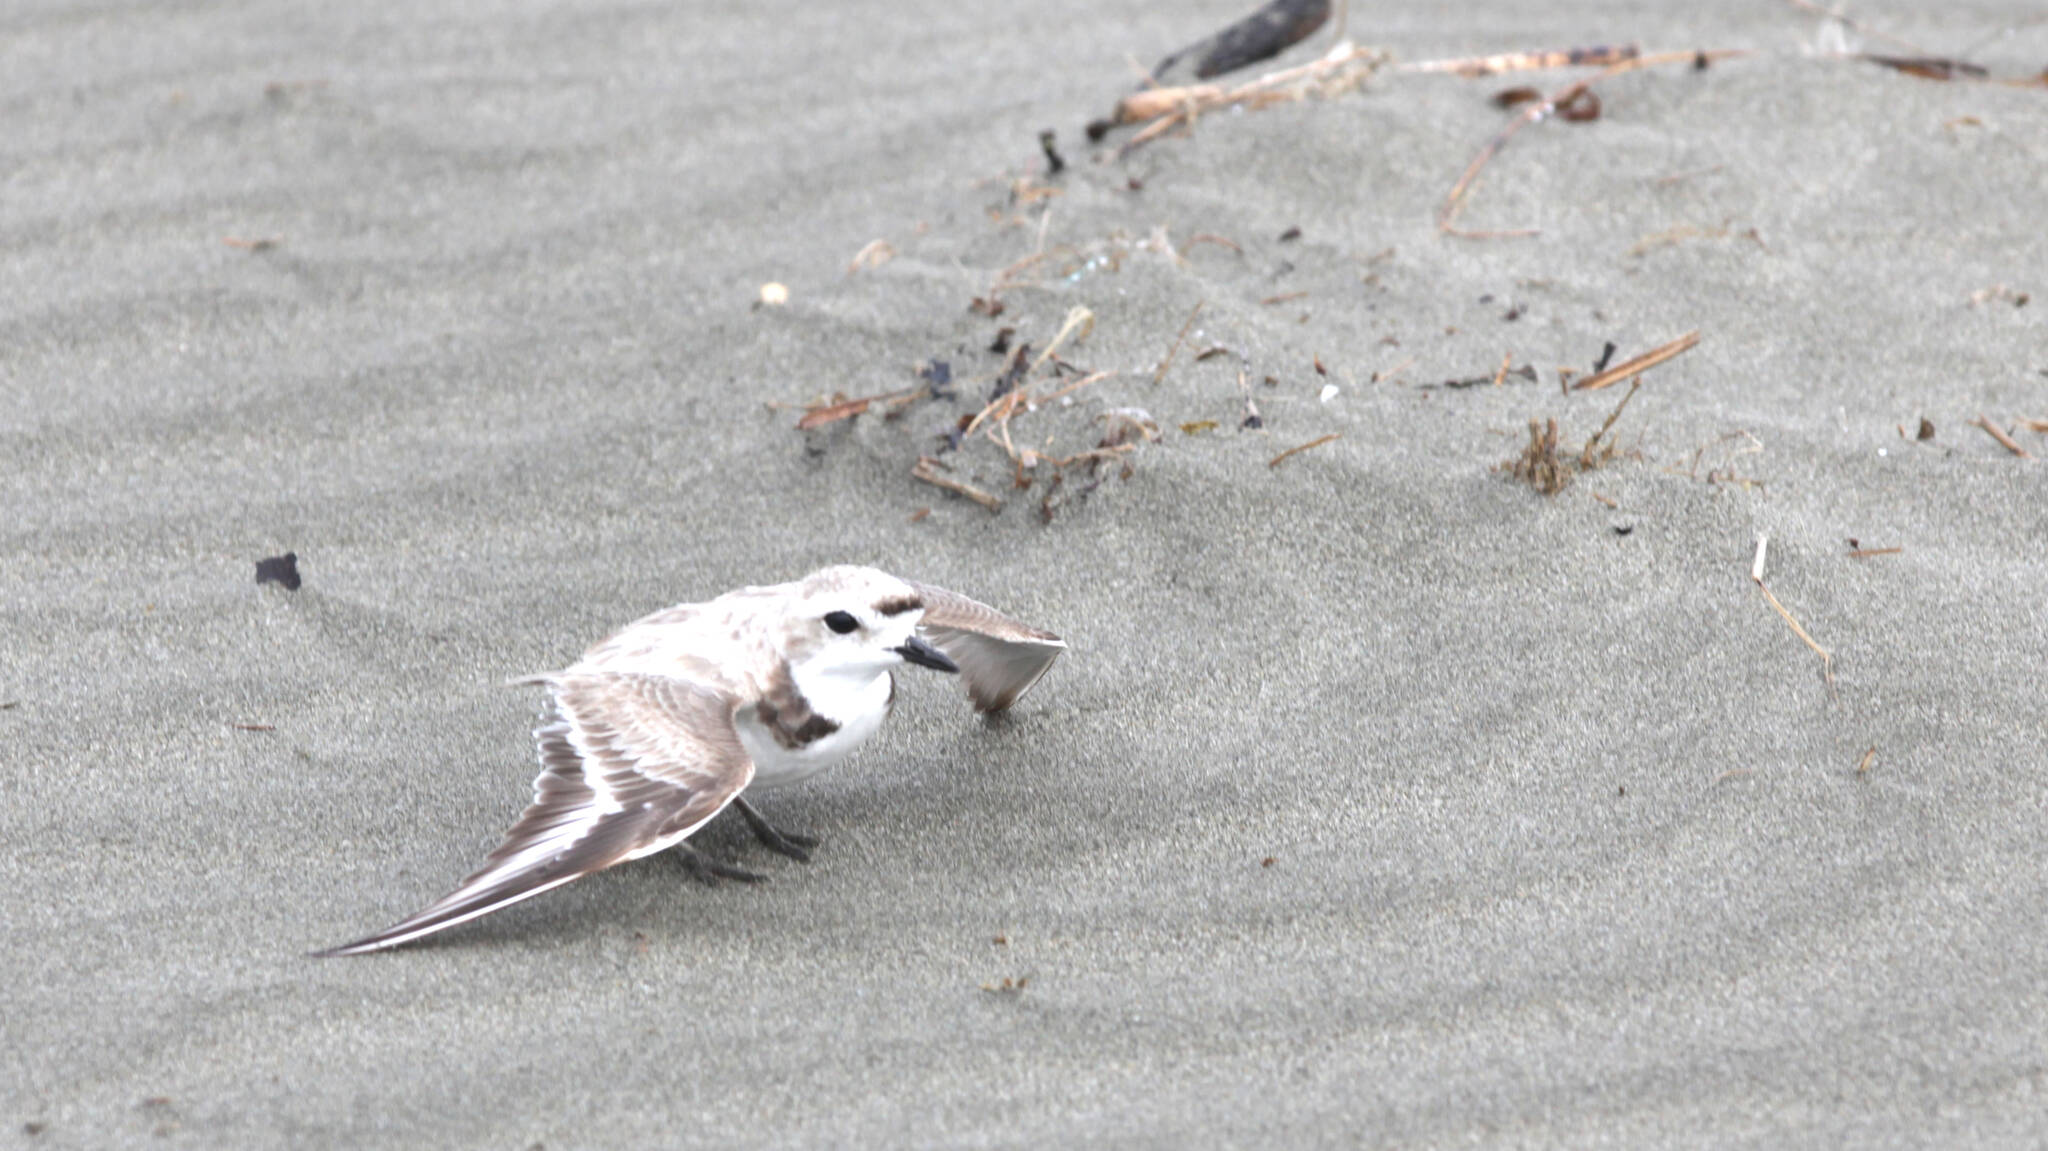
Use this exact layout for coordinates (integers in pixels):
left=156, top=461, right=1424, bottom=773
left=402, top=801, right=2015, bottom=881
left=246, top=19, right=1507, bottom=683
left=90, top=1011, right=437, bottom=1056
left=313, top=567, right=1067, bottom=956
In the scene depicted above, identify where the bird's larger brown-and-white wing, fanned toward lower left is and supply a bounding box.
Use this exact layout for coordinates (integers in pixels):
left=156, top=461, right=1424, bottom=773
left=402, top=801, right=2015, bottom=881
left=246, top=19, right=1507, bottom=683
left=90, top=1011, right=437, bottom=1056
left=315, top=674, right=754, bottom=956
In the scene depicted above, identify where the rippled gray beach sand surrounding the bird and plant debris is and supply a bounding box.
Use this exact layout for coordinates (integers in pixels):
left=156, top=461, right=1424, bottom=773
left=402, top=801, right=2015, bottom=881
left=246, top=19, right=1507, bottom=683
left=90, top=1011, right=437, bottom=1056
left=0, top=0, right=2048, bottom=1149
